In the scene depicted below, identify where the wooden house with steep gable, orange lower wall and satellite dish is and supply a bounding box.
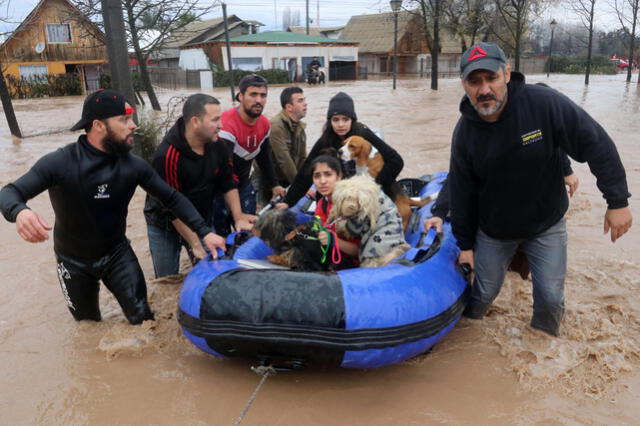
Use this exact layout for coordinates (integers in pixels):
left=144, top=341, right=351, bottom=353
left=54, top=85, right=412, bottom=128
left=0, top=0, right=107, bottom=92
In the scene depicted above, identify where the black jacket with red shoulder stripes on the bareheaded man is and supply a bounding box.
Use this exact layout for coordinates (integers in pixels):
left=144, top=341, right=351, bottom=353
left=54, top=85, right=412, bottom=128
left=144, top=117, right=238, bottom=230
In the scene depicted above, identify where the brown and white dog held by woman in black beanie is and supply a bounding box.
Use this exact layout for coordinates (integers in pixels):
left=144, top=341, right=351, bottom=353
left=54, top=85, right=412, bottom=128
left=340, top=136, right=432, bottom=231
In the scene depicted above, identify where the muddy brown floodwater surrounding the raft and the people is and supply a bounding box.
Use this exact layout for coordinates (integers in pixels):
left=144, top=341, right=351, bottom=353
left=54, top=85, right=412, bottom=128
left=0, top=75, right=640, bottom=425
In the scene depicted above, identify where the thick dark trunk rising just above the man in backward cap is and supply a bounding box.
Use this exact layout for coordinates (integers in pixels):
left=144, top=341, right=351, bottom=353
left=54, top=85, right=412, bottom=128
left=101, top=0, right=137, bottom=110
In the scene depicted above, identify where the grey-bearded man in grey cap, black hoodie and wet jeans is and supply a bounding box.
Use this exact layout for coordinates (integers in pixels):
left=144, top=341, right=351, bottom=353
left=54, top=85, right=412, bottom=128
left=449, top=43, right=632, bottom=335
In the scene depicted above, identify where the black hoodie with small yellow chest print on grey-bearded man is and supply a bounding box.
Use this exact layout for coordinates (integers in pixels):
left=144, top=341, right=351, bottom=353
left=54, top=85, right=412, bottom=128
left=449, top=72, right=631, bottom=250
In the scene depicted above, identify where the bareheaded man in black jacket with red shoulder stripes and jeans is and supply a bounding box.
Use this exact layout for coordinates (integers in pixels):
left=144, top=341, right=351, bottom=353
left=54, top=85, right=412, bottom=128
left=144, top=93, right=255, bottom=277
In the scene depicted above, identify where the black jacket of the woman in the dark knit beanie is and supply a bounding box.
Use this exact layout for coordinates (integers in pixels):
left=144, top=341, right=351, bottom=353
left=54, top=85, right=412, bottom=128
left=284, top=122, right=404, bottom=206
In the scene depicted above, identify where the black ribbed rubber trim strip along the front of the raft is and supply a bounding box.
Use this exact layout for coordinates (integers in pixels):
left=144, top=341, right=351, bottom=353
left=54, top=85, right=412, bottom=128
left=178, top=286, right=470, bottom=351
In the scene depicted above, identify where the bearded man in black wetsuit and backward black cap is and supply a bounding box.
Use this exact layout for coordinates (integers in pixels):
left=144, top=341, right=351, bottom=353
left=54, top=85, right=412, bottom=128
left=0, top=90, right=224, bottom=324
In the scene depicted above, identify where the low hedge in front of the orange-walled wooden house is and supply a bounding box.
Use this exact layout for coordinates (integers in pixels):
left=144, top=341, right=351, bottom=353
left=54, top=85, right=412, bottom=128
left=6, top=74, right=82, bottom=99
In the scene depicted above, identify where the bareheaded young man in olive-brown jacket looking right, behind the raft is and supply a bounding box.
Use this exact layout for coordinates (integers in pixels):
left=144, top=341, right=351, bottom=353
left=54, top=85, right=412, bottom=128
left=253, top=86, right=307, bottom=205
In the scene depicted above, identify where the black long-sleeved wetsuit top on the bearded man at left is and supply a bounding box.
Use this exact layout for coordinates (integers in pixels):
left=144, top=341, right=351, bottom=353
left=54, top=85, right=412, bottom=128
left=0, top=135, right=210, bottom=259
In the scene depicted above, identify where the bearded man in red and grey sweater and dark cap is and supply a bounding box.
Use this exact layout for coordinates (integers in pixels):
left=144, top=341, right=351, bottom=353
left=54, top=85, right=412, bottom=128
left=214, top=74, right=285, bottom=235
